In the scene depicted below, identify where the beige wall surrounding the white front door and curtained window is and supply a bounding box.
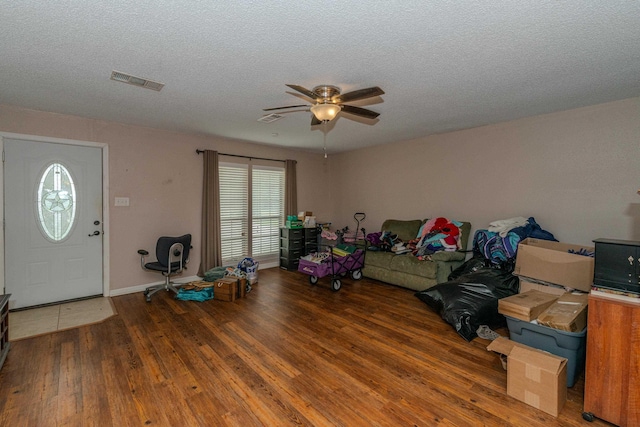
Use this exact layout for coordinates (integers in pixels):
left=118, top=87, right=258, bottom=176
left=0, top=105, right=332, bottom=292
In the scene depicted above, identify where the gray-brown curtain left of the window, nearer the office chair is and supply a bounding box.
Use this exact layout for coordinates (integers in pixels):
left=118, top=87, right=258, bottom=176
left=198, top=150, right=222, bottom=277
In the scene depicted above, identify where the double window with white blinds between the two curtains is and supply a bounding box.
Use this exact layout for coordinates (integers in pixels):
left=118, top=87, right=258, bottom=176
left=219, top=162, right=285, bottom=264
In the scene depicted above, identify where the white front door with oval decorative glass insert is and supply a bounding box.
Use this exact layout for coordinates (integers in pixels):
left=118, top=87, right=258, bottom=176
left=4, top=138, right=103, bottom=308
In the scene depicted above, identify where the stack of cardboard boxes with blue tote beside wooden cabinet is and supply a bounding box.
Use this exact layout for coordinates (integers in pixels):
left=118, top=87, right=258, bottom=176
left=488, top=238, right=594, bottom=416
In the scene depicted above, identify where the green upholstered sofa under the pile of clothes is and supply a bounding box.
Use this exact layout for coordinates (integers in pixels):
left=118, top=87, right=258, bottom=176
left=362, top=219, right=471, bottom=291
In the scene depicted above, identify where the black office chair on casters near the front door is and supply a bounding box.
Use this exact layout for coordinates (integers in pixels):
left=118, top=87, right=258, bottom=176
left=138, top=234, right=191, bottom=302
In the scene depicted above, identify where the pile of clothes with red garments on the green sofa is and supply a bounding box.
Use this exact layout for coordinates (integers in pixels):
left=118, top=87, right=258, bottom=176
left=366, top=217, right=462, bottom=259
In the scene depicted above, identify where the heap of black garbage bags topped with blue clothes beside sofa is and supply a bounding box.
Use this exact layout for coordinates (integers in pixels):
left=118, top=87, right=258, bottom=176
left=415, top=217, right=557, bottom=341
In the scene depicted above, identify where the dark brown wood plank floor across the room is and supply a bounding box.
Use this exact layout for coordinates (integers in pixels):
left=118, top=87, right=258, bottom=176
left=0, top=269, right=607, bottom=427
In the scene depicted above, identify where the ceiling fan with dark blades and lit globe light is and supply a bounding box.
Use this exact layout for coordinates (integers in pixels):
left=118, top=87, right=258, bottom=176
left=263, top=84, right=384, bottom=126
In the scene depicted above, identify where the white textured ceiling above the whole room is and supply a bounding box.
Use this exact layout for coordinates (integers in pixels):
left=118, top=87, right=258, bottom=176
left=0, top=0, right=640, bottom=152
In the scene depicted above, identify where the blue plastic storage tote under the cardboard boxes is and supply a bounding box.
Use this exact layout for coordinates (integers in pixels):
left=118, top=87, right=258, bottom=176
left=505, top=316, right=587, bottom=387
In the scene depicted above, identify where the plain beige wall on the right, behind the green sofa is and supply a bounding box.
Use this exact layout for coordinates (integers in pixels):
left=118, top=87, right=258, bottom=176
left=330, top=98, right=640, bottom=245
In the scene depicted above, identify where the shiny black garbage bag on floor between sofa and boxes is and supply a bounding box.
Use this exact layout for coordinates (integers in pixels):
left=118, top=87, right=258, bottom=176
left=415, top=266, right=520, bottom=341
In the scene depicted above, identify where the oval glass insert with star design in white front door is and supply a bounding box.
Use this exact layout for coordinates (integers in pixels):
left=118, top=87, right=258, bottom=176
left=36, top=163, right=76, bottom=242
